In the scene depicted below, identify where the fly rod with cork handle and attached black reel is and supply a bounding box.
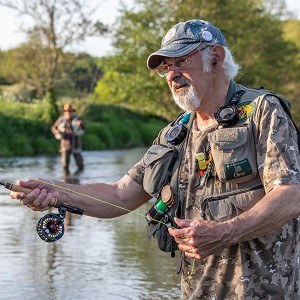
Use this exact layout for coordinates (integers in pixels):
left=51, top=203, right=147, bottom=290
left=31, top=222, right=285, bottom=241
left=0, top=182, right=83, bottom=243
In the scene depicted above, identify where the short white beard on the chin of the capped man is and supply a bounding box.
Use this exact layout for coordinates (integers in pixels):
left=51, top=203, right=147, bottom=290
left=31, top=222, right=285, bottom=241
left=172, top=83, right=201, bottom=111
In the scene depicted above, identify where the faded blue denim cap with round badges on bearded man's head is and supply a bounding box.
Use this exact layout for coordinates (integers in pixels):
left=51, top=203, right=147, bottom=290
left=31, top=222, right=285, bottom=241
left=147, top=20, right=227, bottom=69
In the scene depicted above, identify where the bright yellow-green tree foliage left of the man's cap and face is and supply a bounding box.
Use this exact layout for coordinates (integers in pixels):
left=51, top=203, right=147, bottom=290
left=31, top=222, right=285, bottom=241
left=95, top=6, right=178, bottom=118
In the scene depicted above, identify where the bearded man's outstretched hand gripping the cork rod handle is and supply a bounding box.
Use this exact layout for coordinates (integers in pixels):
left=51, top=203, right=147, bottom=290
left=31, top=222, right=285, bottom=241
left=10, top=179, right=59, bottom=211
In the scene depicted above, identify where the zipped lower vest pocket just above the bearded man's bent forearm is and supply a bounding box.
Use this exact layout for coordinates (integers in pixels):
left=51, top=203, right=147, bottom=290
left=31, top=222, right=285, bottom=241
left=201, top=185, right=265, bottom=222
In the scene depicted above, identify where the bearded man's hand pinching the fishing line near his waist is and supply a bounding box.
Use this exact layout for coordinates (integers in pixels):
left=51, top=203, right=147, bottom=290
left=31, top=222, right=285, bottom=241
left=169, top=218, right=233, bottom=259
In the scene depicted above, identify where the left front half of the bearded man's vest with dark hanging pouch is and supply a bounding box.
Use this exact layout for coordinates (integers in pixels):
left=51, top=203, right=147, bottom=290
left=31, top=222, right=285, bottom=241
left=142, top=113, right=195, bottom=257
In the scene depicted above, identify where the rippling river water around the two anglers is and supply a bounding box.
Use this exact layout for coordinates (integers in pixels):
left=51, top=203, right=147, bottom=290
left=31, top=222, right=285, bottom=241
left=0, top=148, right=180, bottom=300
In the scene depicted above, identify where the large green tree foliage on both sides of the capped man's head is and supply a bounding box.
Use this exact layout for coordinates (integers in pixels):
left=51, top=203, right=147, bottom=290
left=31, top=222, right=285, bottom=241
left=95, top=0, right=299, bottom=122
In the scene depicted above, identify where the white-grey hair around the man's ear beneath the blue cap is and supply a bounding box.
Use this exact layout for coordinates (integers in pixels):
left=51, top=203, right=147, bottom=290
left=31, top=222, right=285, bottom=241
left=202, top=46, right=240, bottom=79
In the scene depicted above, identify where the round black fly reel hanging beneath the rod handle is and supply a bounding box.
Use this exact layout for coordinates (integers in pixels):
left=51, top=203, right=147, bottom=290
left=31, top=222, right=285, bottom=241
left=36, top=203, right=83, bottom=243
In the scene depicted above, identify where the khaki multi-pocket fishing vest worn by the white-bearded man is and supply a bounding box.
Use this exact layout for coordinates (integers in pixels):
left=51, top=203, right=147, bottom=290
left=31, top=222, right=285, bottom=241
left=143, top=83, right=298, bottom=253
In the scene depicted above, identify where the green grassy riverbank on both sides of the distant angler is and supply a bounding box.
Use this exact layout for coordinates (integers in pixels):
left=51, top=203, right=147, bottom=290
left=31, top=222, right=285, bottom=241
left=0, top=100, right=167, bottom=156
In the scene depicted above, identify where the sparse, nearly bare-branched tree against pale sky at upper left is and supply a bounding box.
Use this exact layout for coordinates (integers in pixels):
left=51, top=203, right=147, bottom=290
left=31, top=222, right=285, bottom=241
left=0, top=0, right=107, bottom=97
